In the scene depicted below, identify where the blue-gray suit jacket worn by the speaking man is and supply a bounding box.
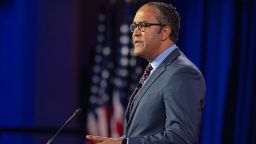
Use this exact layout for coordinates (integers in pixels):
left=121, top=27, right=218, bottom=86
left=124, top=48, right=205, bottom=144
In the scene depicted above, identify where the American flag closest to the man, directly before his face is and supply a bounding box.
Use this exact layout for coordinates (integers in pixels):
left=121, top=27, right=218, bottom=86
left=111, top=1, right=142, bottom=138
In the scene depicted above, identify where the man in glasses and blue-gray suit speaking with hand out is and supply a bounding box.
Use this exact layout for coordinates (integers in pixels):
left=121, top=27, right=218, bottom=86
left=87, top=2, right=205, bottom=144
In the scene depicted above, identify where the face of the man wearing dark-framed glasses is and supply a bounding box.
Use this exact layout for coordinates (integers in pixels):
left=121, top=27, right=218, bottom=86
left=132, top=6, right=161, bottom=61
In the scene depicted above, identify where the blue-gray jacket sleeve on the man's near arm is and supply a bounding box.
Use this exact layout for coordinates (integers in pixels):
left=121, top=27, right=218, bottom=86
left=129, top=67, right=205, bottom=144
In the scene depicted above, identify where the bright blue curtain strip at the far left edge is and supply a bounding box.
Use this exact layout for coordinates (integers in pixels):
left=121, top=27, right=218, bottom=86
left=0, top=0, right=36, bottom=144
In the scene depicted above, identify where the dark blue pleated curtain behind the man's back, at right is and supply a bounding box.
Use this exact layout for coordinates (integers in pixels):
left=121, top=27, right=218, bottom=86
left=174, top=0, right=256, bottom=144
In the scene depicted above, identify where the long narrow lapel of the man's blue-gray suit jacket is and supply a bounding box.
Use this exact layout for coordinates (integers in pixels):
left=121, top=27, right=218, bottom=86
left=126, top=48, right=181, bottom=126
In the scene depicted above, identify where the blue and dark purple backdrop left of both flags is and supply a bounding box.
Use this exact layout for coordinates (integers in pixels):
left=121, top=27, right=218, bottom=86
left=0, top=0, right=83, bottom=144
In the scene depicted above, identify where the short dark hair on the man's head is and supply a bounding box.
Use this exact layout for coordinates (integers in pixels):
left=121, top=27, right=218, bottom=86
left=145, top=2, right=180, bottom=43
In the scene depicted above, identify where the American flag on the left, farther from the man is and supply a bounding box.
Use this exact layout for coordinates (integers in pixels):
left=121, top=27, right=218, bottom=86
left=87, top=5, right=114, bottom=136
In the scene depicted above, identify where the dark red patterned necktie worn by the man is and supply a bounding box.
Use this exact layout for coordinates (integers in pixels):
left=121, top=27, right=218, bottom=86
left=128, top=64, right=153, bottom=118
